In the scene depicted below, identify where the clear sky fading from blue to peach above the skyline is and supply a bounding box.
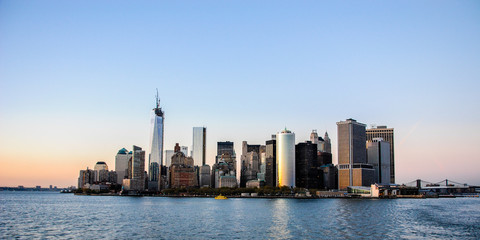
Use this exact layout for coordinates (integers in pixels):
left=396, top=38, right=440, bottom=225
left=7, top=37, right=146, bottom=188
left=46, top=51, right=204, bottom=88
left=0, top=1, right=480, bottom=186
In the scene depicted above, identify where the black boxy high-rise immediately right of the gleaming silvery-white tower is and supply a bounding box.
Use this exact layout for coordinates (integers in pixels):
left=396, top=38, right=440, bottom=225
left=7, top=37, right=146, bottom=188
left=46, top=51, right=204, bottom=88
left=295, top=141, right=323, bottom=189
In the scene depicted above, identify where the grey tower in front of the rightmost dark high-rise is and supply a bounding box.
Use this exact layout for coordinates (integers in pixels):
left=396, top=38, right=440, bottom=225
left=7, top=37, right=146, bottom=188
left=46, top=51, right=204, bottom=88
left=367, top=138, right=391, bottom=184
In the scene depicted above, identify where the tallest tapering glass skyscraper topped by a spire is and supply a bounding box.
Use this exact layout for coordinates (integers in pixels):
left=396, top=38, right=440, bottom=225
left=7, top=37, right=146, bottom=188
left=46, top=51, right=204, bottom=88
left=148, top=91, right=165, bottom=181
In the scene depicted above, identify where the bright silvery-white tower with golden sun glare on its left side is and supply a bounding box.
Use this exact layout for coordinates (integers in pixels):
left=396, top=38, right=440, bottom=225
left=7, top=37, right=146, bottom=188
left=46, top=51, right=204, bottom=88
left=276, top=128, right=295, bottom=187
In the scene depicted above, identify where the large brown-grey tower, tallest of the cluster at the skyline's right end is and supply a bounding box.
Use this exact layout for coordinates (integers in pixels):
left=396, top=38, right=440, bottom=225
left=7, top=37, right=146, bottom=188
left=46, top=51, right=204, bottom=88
left=337, top=118, right=374, bottom=190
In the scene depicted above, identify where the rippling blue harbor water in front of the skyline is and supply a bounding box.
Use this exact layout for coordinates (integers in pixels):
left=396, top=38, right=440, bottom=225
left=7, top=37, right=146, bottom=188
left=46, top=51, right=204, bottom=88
left=0, top=191, right=480, bottom=239
